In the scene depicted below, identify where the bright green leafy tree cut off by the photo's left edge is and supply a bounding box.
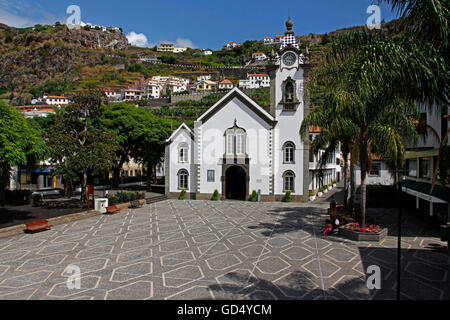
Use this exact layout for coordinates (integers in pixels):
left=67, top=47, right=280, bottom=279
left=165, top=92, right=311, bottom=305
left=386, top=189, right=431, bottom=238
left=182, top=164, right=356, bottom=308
left=0, top=100, right=47, bottom=205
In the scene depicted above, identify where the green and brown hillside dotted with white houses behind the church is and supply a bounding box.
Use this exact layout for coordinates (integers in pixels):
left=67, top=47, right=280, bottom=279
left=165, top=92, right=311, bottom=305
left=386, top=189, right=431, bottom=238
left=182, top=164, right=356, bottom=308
left=0, top=21, right=398, bottom=106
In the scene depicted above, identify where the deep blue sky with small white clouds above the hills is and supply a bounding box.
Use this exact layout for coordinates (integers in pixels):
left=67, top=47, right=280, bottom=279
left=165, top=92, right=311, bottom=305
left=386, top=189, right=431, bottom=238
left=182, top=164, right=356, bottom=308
left=0, top=0, right=395, bottom=49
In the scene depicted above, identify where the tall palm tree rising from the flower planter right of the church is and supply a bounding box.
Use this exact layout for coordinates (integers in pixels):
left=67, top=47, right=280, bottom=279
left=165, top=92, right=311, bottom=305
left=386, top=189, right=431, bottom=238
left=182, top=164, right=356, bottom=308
left=303, top=32, right=448, bottom=225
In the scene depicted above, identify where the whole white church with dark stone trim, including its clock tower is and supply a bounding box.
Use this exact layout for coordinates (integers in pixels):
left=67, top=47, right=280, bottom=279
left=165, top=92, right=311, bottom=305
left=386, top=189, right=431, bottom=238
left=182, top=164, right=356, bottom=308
left=165, top=20, right=334, bottom=202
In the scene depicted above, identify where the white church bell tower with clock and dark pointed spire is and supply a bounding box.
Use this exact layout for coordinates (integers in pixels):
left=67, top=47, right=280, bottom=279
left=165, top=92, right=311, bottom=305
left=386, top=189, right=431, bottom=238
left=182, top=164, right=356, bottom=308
left=268, top=19, right=309, bottom=201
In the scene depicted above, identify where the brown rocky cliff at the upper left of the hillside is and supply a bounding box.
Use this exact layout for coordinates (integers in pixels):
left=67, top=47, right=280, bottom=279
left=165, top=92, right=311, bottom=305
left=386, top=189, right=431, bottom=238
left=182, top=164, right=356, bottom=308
left=0, top=24, right=128, bottom=92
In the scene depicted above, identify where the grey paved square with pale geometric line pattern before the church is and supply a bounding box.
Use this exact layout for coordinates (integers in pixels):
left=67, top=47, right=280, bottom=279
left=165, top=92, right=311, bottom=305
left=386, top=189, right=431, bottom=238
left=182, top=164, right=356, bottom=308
left=0, top=200, right=450, bottom=300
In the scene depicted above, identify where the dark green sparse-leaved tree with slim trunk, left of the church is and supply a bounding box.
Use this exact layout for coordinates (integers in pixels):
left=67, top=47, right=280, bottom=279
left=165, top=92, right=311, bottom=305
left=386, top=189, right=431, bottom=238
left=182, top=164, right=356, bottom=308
left=47, top=90, right=117, bottom=201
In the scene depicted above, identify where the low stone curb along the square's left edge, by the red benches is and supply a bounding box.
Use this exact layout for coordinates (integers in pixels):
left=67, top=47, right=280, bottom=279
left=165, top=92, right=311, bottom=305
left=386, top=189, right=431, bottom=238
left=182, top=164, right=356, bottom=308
left=0, top=200, right=146, bottom=239
